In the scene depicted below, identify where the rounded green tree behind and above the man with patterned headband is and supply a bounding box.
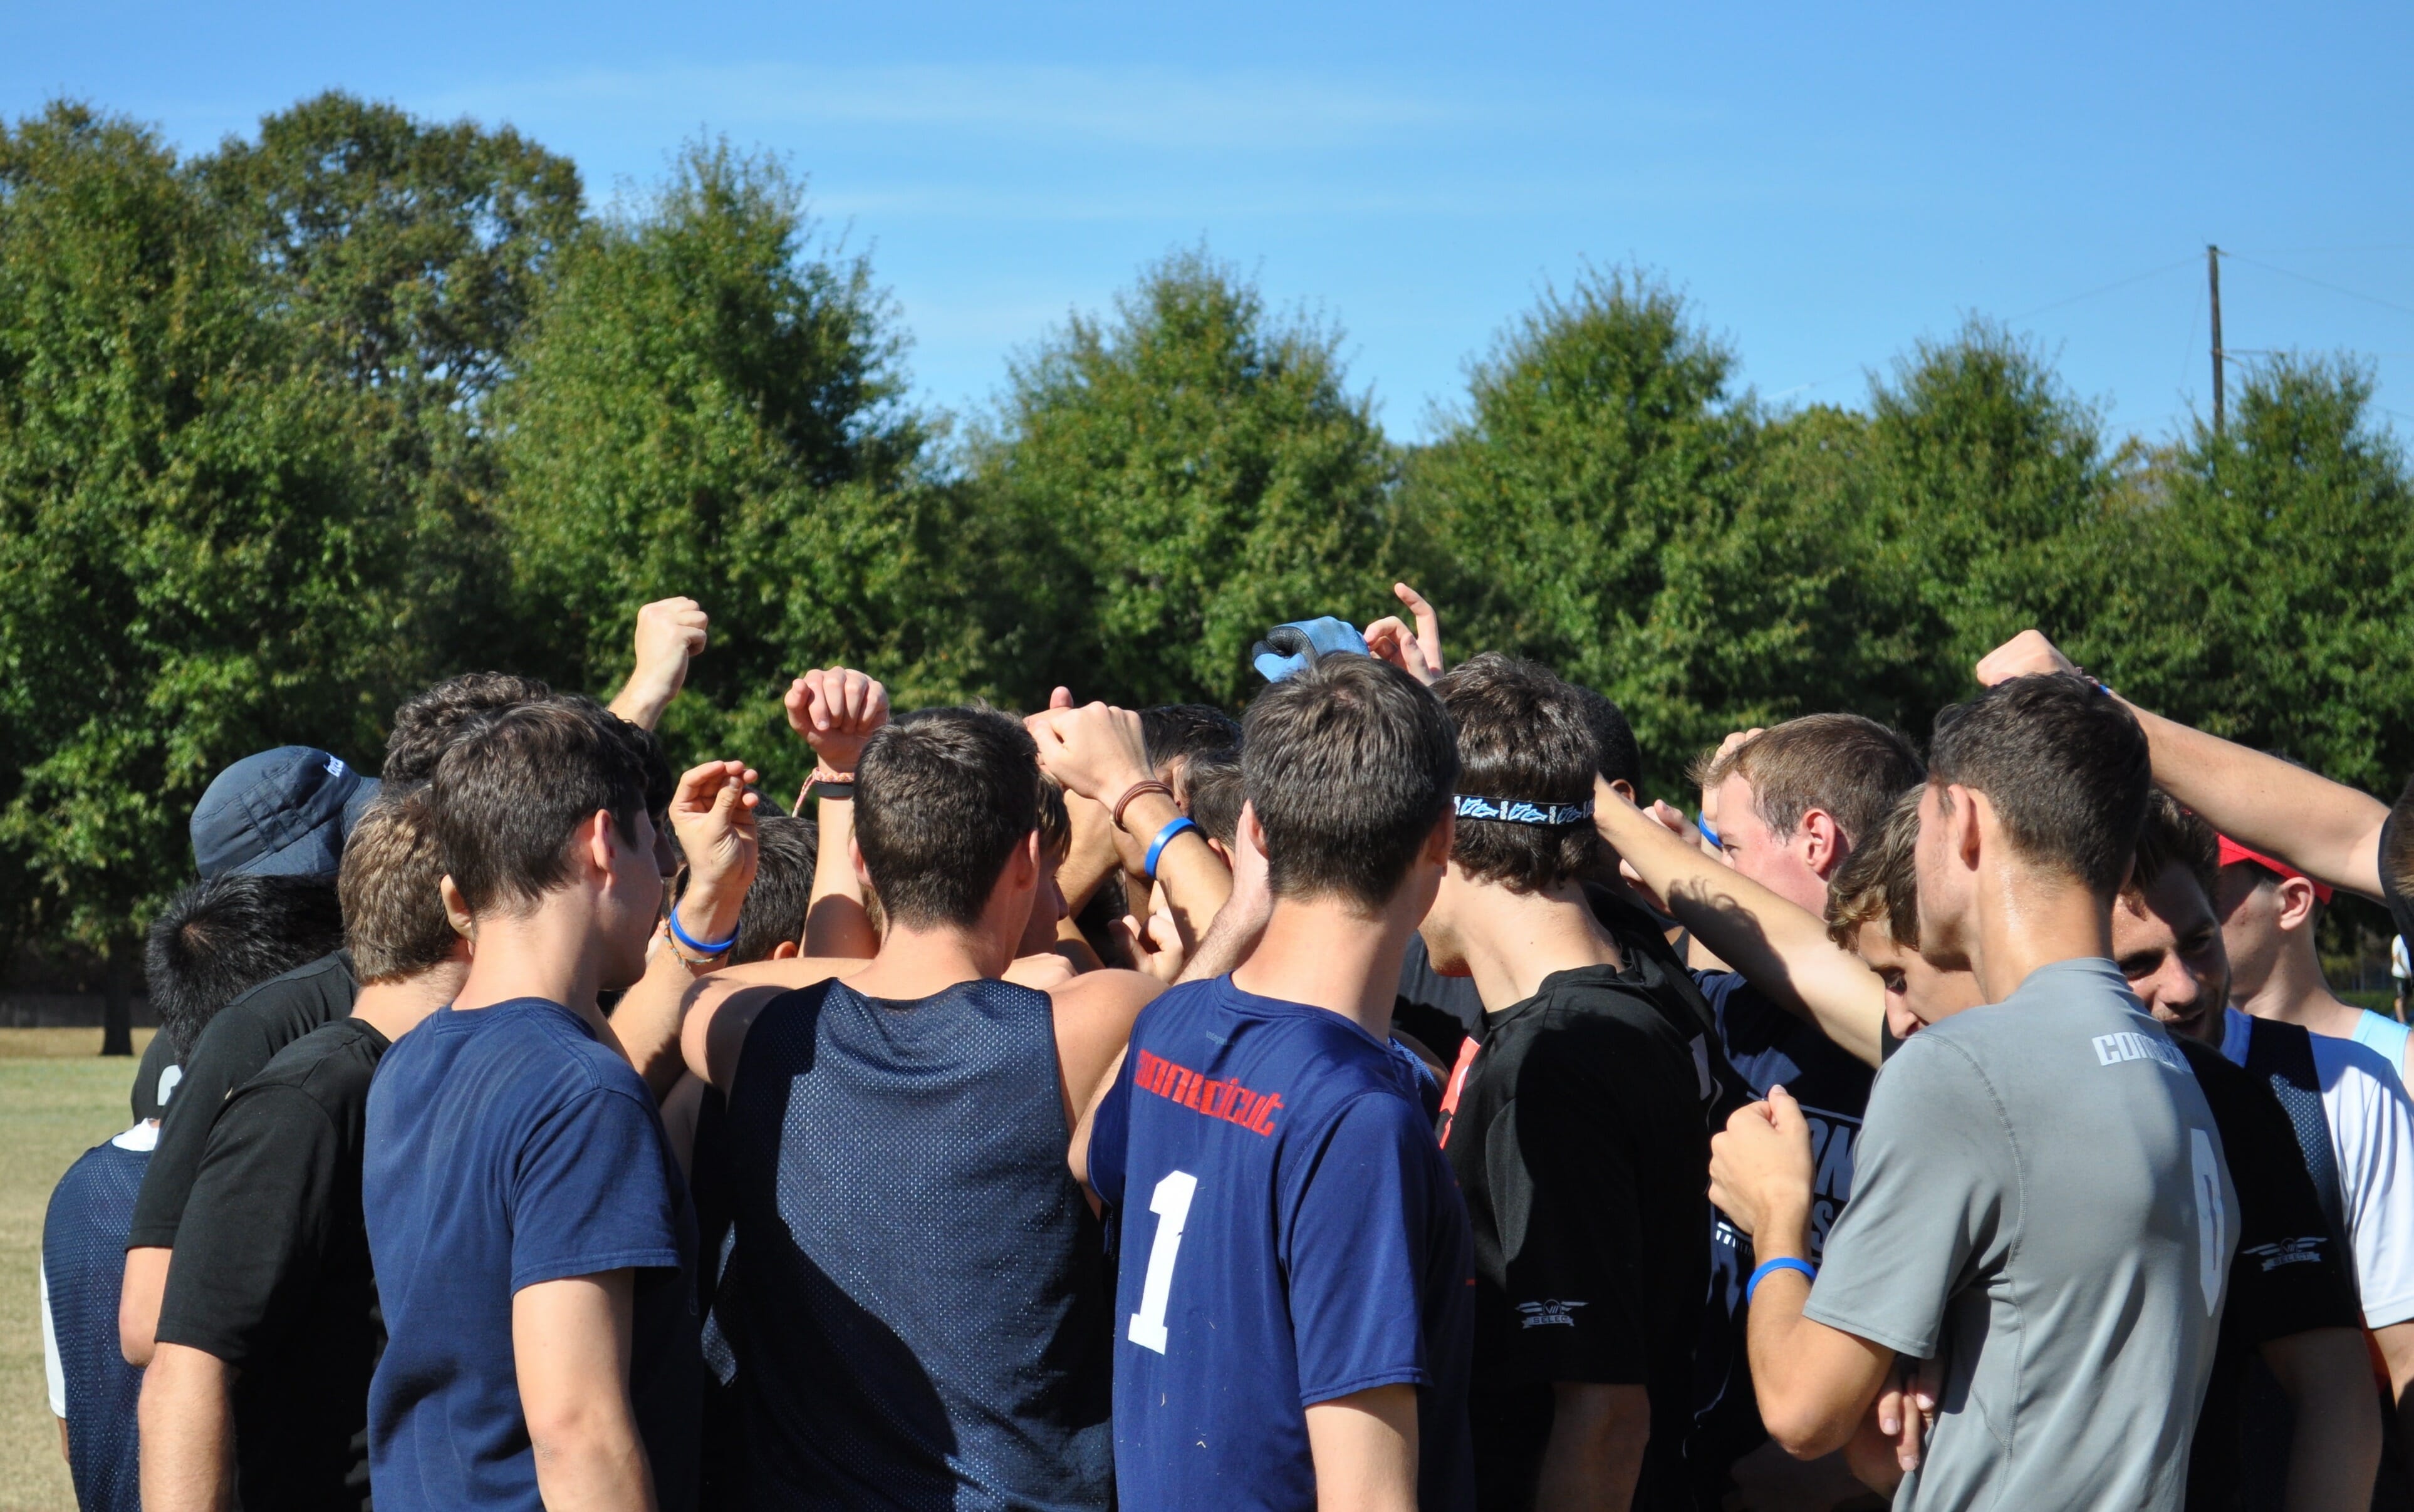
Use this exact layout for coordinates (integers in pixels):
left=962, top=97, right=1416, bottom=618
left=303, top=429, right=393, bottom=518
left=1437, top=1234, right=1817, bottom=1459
left=1407, top=270, right=1856, bottom=786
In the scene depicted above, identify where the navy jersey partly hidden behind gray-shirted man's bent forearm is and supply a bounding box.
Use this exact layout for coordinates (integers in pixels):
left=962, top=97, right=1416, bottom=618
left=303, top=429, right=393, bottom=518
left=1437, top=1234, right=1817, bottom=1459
left=1687, top=972, right=1876, bottom=1490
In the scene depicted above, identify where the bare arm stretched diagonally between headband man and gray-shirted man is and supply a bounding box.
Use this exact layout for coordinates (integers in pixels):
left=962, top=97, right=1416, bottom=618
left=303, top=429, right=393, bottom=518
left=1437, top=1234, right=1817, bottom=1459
left=1593, top=784, right=1885, bottom=1066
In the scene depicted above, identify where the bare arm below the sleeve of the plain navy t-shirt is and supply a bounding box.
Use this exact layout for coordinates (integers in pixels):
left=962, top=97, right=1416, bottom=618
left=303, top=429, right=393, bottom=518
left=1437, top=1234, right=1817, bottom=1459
left=512, top=1271, right=654, bottom=1512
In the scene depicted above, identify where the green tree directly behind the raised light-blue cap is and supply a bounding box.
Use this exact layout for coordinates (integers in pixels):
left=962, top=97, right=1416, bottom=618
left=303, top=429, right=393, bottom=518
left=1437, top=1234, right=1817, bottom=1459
left=973, top=251, right=1393, bottom=707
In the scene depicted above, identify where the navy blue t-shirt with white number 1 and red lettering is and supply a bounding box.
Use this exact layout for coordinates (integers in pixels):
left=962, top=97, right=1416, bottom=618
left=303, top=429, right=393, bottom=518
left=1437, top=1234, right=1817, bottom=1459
left=1089, top=976, right=1475, bottom=1512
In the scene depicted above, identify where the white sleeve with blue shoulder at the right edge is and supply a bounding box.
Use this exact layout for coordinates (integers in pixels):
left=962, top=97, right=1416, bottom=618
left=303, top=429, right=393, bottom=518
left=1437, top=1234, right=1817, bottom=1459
left=2313, top=1035, right=2414, bottom=1328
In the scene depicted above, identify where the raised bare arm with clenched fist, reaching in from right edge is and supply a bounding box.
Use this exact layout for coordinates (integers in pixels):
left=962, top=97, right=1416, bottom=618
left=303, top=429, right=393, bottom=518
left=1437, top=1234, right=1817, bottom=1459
left=1977, top=629, right=2390, bottom=902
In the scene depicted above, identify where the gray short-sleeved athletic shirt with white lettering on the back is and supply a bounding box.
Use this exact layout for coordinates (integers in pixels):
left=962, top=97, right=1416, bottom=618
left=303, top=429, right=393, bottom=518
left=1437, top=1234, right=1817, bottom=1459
left=1803, top=960, right=2238, bottom=1512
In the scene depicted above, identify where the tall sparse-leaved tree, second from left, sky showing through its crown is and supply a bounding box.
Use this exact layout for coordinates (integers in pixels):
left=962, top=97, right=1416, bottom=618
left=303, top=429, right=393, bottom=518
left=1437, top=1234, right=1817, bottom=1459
left=193, top=91, right=582, bottom=675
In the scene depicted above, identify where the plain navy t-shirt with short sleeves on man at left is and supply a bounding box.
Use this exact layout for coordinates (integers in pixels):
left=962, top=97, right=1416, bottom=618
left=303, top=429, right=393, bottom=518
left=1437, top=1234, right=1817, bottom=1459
left=362, top=998, right=702, bottom=1512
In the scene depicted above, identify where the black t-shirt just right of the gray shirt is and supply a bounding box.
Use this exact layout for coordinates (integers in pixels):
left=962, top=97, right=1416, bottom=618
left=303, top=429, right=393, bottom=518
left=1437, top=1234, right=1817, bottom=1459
left=2173, top=1035, right=2363, bottom=1512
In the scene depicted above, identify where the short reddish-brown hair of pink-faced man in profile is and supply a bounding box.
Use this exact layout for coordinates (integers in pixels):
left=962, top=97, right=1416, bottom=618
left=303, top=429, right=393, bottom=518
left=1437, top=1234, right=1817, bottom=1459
left=1692, top=714, right=1927, bottom=844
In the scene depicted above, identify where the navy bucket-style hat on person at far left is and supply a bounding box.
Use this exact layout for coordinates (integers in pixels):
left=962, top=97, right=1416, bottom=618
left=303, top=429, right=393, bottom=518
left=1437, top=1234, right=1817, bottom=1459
left=193, top=745, right=379, bottom=878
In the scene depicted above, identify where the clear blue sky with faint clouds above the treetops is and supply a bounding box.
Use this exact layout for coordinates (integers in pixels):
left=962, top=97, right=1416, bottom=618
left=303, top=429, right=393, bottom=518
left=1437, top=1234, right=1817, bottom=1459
left=19, top=0, right=2414, bottom=437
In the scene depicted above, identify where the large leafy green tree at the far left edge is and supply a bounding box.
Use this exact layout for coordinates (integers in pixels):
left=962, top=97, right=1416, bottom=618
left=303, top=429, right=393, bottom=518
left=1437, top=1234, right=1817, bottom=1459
left=0, top=104, right=401, bottom=1037
